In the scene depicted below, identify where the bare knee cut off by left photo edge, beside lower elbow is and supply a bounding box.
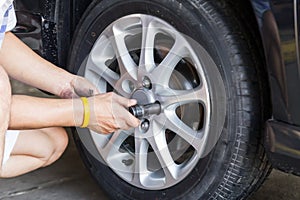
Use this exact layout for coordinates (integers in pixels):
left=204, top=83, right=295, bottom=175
left=0, top=66, right=11, bottom=175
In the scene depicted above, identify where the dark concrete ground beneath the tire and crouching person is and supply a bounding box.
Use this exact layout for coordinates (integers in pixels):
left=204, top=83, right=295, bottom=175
left=0, top=82, right=300, bottom=200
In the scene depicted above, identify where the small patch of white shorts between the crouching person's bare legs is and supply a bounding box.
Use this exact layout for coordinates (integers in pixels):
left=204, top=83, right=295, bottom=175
left=2, top=130, right=20, bottom=166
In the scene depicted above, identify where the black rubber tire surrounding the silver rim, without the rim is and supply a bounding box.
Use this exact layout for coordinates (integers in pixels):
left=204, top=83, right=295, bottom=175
left=69, top=0, right=270, bottom=199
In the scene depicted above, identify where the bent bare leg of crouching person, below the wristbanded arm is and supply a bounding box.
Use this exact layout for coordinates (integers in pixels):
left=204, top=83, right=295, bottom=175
left=1, top=128, right=68, bottom=178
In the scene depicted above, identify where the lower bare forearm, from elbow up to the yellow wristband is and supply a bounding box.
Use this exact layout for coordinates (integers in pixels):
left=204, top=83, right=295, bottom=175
left=9, top=95, right=84, bottom=129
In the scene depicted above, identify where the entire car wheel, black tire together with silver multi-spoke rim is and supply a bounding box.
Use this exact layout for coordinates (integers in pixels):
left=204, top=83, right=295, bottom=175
left=69, top=0, right=270, bottom=200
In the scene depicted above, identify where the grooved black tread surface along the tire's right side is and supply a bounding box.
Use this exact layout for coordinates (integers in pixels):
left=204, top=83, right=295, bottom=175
left=192, top=0, right=271, bottom=199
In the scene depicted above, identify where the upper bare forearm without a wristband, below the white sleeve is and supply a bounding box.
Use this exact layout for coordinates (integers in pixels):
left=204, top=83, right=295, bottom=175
left=0, top=32, right=74, bottom=95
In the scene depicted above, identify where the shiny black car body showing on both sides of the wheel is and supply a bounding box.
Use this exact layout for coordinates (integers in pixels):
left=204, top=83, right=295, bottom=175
left=14, top=0, right=300, bottom=199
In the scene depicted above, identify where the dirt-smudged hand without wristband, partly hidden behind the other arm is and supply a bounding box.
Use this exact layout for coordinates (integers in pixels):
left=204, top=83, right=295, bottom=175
left=59, top=75, right=99, bottom=99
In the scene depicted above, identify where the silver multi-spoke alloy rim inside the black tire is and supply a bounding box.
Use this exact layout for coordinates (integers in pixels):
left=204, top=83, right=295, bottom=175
left=84, top=14, right=211, bottom=190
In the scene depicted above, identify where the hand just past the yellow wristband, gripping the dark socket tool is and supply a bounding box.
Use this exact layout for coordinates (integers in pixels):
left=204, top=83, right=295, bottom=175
left=88, top=92, right=140, bottom=134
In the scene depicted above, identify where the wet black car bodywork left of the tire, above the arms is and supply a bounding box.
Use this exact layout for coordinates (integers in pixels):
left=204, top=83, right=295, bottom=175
left=14, top=0, right=91, bottom=66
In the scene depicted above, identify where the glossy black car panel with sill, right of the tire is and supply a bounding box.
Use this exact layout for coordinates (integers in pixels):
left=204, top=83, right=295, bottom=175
left=252, top=0, right=300, bottom=173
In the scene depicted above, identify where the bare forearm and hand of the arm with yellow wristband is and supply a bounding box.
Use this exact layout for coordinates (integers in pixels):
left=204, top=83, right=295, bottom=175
left=9, top=93, right=139, bottom=133
